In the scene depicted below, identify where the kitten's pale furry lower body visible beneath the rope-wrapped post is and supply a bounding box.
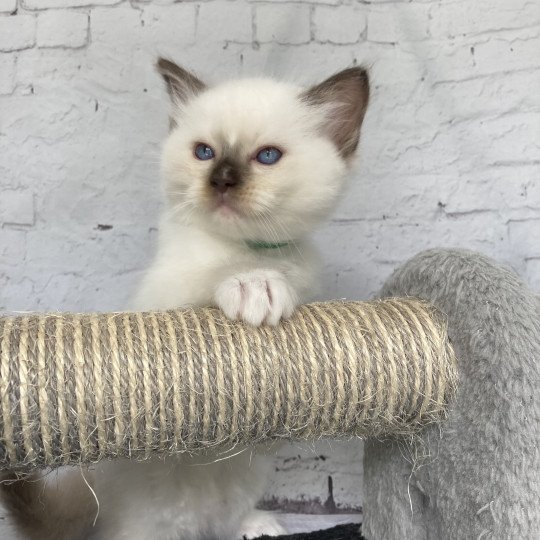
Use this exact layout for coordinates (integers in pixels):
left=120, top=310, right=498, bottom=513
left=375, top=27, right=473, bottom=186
left=90, top=449, right=282, bottom=540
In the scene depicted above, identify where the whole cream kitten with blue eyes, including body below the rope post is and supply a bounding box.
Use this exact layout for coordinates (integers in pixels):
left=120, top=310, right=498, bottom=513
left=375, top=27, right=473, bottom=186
left=0, top=59, right=369, bottom=540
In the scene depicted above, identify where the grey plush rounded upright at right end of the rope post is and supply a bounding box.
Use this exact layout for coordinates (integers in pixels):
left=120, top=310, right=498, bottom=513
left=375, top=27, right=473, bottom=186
left=363, top=250, right=540, bottom=540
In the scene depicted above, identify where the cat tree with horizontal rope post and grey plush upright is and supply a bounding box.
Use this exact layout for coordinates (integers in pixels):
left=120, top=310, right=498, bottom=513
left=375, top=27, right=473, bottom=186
left=0, top=250, right=540, bottom=540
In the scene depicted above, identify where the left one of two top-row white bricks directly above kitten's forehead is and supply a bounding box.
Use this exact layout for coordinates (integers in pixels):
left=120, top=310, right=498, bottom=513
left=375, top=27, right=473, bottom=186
left=197, top=1, right=253, bottom=43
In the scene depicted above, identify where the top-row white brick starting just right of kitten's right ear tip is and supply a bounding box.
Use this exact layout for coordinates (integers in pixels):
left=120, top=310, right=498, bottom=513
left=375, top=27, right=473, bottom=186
left=367, top=4, right=429, bottom=43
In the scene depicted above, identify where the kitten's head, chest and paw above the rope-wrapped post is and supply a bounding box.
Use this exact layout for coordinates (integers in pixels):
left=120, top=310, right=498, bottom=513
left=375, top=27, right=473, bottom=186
left=134, top=59, right=368, bottom=325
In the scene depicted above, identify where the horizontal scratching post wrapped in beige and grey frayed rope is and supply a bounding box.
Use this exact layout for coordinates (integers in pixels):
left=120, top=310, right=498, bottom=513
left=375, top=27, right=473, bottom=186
left=0, top=299, right=457, bottom=468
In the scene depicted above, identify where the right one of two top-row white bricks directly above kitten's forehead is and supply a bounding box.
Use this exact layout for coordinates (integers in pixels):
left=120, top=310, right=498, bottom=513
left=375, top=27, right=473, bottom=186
left=255, top=4, right=311, bottom=44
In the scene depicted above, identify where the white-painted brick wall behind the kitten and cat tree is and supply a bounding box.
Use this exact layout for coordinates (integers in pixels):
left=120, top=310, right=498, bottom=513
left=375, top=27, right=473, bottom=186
left=0, top=0, right=540, bottom=532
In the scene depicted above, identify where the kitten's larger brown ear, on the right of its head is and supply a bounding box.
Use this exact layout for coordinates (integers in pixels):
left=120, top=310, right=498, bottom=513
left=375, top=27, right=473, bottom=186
left=302, top=67, right=369, bottom=158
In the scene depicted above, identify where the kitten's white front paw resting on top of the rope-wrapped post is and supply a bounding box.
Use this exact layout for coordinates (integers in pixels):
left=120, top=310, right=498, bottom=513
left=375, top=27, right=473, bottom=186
left=215, top=270, right=298, bottom=326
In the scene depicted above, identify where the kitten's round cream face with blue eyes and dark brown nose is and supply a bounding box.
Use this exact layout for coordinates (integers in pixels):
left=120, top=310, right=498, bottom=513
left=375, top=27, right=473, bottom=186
left=157, top=60, right=365, bottom=242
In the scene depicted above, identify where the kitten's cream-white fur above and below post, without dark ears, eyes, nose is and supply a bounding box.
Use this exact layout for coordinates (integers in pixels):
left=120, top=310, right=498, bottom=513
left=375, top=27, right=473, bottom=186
left=88, top=76, right=346, bottom=540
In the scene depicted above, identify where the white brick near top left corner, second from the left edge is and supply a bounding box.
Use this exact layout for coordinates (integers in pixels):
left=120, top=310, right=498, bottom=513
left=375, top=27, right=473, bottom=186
left=37, top=10, right=88, bottom=48
